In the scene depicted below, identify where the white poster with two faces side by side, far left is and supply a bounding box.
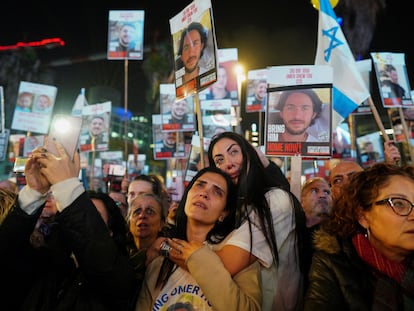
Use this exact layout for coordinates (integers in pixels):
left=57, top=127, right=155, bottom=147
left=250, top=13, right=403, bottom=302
left=11, top=81, right=57, bottom=134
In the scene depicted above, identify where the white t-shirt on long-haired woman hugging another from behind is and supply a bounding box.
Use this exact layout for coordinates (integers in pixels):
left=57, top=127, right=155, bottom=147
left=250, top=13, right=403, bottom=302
left=215, top=188, right=303, bottom=311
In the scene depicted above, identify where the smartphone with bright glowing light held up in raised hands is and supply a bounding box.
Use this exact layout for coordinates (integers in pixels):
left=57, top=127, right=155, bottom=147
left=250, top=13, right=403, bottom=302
left=45, top=114, right=82, bottom=159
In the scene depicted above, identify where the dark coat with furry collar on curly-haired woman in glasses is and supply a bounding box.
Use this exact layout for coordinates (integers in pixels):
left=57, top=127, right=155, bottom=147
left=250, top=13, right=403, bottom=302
left=305, top=230, right=414, bottom=311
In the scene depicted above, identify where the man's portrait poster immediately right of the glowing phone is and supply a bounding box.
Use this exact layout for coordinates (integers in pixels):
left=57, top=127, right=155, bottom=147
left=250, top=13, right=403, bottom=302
left=79, top=101, right=112, bottom=152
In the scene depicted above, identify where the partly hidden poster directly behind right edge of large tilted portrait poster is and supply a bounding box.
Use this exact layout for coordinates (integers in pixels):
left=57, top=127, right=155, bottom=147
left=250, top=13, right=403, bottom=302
left=199, top=48, right=241, bottom=106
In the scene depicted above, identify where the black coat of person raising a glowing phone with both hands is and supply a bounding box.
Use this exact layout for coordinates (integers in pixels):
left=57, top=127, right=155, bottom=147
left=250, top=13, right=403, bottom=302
left=0, top=192, right=136, bottom=311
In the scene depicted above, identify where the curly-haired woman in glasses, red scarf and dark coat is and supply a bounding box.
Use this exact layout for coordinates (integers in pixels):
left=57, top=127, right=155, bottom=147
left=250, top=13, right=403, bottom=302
left=305, top=163, right=414, bottom=311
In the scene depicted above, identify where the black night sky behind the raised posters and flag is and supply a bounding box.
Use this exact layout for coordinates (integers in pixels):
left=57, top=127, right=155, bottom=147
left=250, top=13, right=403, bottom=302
left=0, top=0, right=414, bottom=160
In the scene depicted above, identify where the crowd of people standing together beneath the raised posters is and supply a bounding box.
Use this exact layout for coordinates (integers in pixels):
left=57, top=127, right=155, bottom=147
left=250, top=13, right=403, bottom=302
left=0, top=132, right=414, bottom=311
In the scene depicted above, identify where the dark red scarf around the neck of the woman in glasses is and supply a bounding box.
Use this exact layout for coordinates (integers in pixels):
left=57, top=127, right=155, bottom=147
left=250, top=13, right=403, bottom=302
left=352, top=233, right=405, bottom=284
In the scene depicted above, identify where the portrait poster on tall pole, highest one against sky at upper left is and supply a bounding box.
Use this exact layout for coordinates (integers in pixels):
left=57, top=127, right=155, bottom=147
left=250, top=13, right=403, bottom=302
left=107, top=10, right=144, bottom=60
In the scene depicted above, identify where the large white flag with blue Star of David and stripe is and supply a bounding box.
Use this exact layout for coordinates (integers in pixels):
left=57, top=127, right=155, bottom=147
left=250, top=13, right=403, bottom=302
left=315, top=0, right=370, bottom=129
